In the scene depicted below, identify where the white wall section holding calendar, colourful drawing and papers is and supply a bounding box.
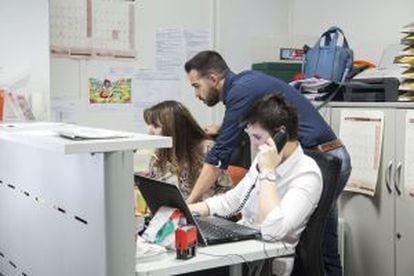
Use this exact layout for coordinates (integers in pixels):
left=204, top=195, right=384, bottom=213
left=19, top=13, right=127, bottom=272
left=50, top=0, right=214, bottom=132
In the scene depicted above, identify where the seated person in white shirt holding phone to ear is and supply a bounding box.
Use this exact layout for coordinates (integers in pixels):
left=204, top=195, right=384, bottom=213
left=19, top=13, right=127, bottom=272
left=190, top=94, right=322, bottom=275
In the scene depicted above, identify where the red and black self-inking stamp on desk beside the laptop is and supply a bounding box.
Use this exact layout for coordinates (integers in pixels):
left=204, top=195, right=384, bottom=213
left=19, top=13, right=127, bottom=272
left=175, top=225, right=197, bottom=260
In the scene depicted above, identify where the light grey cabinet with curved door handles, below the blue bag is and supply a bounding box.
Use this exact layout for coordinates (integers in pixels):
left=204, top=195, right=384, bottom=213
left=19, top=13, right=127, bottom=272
left=329, top=103, right=414, bottom=276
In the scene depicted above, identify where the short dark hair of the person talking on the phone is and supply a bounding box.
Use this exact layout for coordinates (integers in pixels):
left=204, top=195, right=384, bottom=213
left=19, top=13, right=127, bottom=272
left=242, top=92, right=298, bottom=140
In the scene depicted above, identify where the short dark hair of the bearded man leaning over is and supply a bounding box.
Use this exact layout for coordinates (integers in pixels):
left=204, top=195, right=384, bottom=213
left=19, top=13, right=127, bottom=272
left=184, top=50, right=229, bottom=78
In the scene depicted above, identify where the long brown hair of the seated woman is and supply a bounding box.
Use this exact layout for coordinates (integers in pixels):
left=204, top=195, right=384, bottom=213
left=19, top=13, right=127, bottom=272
left=144, top=101, right=210, bottom=185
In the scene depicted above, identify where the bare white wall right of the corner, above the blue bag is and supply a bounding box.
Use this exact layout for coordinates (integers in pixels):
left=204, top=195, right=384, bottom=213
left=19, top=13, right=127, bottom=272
left=289, top=0, right=414, bottom=63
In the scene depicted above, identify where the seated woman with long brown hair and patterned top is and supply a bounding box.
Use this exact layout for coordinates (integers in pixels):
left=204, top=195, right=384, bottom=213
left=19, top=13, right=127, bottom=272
left=144, top=101, right=231, bottom=199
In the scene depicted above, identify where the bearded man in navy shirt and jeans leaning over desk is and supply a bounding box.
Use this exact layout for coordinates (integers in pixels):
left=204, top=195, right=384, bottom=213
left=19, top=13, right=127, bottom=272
left=185, top=51, right=351, bottom=276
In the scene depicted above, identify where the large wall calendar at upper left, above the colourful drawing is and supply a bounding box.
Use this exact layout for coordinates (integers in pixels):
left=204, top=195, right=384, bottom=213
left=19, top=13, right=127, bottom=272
left=50, top=0, right=136, bottom=59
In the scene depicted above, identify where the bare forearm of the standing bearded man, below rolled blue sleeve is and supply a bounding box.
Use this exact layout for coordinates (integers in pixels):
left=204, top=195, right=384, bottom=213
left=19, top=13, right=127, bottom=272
left=187, top=163, right=220, bottom=204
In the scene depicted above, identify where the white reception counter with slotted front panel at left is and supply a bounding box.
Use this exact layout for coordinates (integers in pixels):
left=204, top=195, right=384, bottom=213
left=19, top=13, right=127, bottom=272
left=0, top=123, right=171, bottom=276
